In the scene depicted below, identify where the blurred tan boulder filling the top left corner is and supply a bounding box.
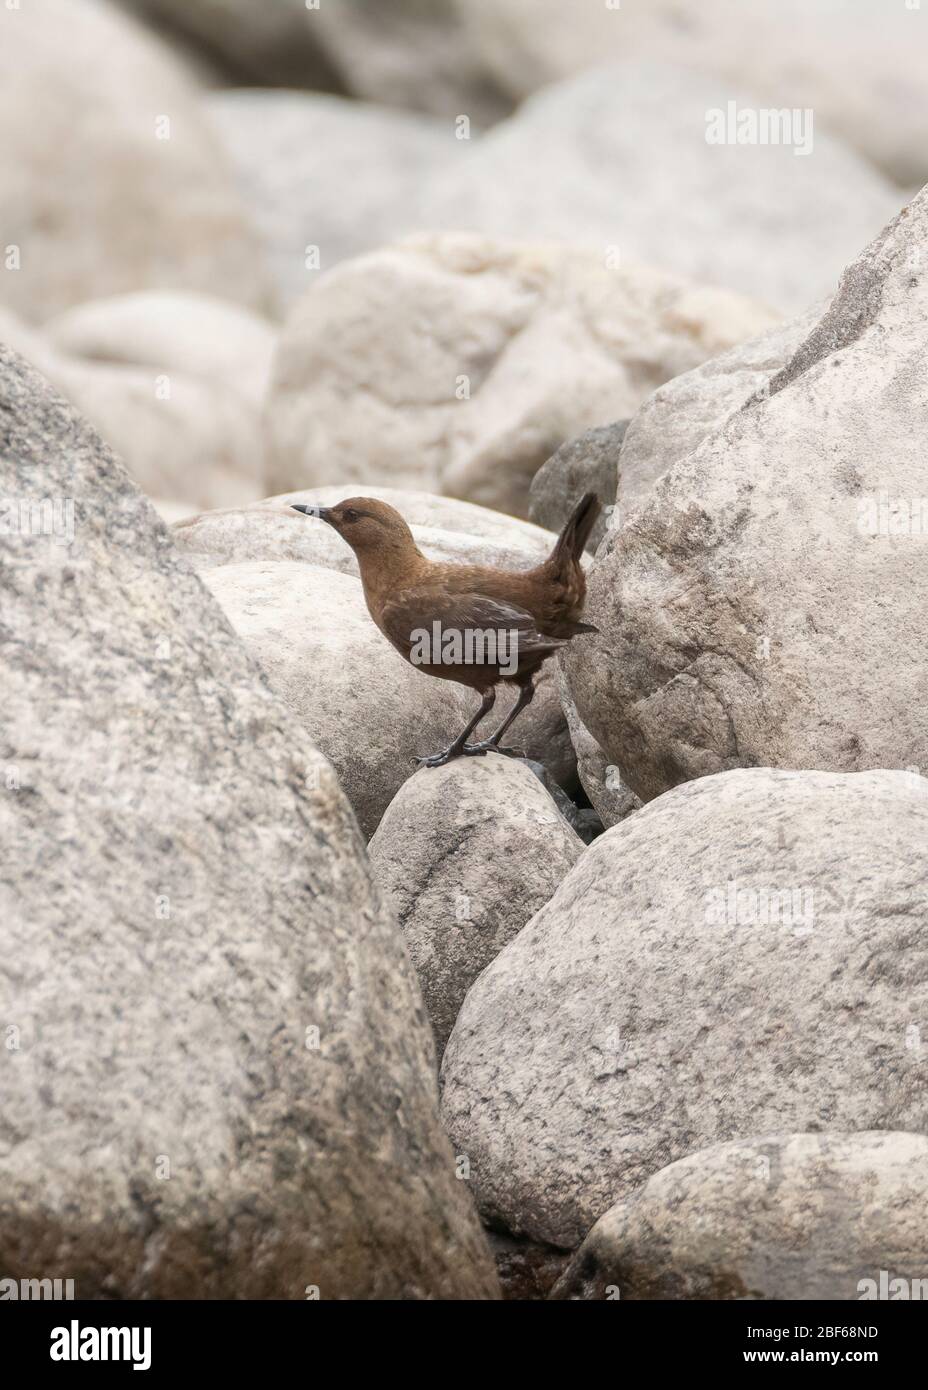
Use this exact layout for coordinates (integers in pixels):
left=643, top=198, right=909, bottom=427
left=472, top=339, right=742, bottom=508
left=0, top=0, right=265, bottom=321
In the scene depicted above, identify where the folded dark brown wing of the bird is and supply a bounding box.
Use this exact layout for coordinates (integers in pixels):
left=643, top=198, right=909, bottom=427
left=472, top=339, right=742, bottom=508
left=381, top=588, right=565, bottom=664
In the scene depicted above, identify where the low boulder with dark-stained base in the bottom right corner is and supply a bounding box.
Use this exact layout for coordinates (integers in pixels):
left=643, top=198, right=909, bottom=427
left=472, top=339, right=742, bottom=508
left=553, top=1131, right=928, bottom=1301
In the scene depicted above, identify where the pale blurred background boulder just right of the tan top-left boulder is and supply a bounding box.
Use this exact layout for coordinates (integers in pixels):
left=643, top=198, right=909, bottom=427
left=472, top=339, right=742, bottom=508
left=207, top=90, right=457, bottom=309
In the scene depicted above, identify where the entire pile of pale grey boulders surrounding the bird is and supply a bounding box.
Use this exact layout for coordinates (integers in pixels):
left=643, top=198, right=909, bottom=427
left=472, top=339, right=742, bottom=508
left=0, top=0, right=928, bottom=1300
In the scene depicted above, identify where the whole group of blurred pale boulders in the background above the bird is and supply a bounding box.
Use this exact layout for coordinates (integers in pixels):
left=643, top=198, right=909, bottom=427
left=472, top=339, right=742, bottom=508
left=0, top=0, right=928, bottom=516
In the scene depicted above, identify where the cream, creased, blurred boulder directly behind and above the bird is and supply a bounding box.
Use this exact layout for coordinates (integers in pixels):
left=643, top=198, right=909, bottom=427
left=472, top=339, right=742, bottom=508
left=268, top=235, right=774, bottom=516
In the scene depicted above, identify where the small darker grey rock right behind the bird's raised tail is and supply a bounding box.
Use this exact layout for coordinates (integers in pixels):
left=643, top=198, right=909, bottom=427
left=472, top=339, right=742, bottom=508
left=528, top=422, right=627, bottom=555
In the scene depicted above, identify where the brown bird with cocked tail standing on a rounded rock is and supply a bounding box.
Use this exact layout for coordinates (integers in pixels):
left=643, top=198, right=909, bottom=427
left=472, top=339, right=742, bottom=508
left=292, top=492, right=599, bottom=767
